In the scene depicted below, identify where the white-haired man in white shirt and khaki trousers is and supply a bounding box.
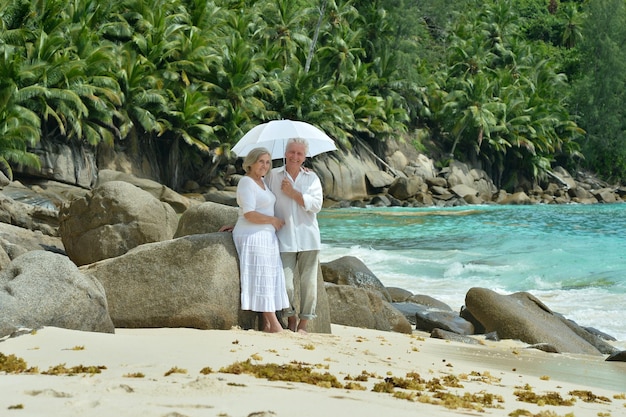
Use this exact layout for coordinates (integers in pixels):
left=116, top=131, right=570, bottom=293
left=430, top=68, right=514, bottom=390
left=266, top=138, right=324, bottom=333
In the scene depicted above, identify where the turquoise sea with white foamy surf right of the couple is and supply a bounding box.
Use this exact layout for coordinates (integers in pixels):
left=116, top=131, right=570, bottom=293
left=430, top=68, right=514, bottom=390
left=318, top=204, right=626, bottom=342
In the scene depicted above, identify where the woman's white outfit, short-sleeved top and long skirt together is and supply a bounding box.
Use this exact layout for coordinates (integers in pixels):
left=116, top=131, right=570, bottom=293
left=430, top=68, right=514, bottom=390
left=233, top=176, right=289, bottom=312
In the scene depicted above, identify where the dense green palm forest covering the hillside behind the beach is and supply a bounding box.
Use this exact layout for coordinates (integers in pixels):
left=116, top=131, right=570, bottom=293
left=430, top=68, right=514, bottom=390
left=0, top=0, right=626, bottom=189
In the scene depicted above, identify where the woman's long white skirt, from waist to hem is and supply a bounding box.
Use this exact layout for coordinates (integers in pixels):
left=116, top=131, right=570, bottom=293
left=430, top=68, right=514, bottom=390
left=233, top=230, right=289, bottom=312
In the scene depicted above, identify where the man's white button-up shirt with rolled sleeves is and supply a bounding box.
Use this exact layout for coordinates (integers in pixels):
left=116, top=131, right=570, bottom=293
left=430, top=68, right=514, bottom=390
left=265, top=167, right=324, bottom=252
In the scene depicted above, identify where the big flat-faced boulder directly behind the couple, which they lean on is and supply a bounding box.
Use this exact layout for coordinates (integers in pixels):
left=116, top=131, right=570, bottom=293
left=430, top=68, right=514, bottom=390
left=81, top=232, right=330, bottom=333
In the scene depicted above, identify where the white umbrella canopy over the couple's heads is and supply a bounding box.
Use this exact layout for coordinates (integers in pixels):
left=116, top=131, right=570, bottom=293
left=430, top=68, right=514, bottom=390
left=232, top=120, right=337, bottom=159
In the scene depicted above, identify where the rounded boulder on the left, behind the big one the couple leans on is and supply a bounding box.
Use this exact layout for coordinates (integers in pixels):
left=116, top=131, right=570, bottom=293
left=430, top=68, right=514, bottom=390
left=59, top=181, right=178, bottom=266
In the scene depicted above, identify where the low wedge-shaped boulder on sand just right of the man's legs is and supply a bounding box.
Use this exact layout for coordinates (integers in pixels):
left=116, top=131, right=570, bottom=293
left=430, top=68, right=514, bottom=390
left=325, top=282, right=413, bottom=334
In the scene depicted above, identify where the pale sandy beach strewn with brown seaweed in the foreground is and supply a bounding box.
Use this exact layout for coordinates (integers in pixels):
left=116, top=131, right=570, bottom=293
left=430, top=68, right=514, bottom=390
left=0, top=325, right=626, bottom=417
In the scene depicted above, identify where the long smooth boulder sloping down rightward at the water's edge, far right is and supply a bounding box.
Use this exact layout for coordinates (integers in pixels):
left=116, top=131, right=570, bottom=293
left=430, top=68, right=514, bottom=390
left=465, top=288, right=600, bottom=355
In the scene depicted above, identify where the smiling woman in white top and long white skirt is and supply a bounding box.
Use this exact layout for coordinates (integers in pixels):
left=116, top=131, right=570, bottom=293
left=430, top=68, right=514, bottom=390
left=233, top=148, right=289, bottom=333
